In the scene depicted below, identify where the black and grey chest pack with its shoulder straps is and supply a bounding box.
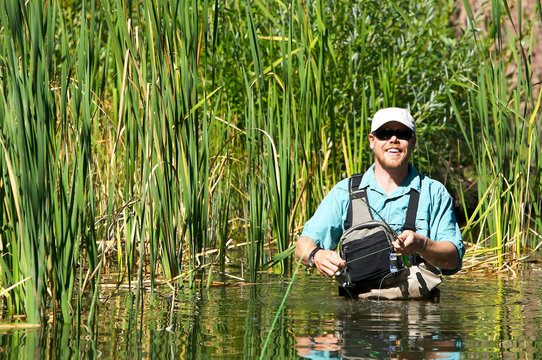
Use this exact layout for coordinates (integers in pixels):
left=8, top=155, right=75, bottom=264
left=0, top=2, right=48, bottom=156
left=337, top=174, right=440, bottom=297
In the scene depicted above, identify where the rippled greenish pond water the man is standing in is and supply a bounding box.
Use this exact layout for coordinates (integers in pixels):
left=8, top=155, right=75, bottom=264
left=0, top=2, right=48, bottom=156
left=0, top=264, right=542, bottom=359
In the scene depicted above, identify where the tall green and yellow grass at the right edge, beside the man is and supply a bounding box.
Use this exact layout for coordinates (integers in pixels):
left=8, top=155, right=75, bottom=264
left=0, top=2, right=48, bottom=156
left=450, top=1, right=542, bottom=266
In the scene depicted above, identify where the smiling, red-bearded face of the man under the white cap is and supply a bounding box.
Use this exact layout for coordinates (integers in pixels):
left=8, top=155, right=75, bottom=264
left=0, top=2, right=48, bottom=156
left=369, top=121, right=416, bottom=170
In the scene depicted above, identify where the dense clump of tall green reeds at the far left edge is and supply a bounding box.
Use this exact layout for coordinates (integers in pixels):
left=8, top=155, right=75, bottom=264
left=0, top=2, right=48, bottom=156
left=0, top=1, right=97, bottom=322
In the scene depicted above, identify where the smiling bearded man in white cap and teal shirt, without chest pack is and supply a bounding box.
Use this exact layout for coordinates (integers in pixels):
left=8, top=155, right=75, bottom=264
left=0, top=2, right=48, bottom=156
left=295, top=108, right=465, bottom=277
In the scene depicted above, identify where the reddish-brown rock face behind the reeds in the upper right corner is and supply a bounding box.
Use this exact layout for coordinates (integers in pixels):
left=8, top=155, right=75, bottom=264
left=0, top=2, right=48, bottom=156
left=453, top=0, right=542, bottom=95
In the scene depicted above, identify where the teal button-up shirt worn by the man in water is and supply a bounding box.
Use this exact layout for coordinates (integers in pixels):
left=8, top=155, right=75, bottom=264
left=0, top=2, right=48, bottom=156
left=301, top=165, right=465, bottom=275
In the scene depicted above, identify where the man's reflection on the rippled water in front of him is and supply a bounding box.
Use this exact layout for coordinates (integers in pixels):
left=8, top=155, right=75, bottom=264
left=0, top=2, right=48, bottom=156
left=296, top=300, right=462, bottom=359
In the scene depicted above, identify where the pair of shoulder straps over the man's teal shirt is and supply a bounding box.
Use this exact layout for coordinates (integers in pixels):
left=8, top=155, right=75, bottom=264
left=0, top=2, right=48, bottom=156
left=344, top=174, right=421, bottom=231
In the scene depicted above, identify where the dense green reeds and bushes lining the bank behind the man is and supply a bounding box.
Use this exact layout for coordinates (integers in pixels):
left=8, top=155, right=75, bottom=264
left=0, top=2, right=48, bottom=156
left=0, top=0, right=542, bottom=323
